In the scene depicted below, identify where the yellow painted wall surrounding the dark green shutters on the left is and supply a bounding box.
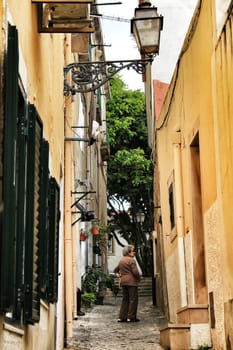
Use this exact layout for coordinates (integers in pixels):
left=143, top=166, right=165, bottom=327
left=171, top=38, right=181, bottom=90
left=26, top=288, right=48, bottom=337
left=0, top=0, right=66, bottom=350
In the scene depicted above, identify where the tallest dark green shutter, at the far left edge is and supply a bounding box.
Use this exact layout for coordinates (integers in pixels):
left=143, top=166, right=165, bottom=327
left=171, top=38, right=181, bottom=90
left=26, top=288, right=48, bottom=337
left=0, top=26, right=18, bottom=310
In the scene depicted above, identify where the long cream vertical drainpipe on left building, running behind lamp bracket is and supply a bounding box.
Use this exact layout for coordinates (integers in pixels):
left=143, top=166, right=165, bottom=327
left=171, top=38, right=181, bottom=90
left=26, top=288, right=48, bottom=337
left=64, top=36, right=73, bottom=340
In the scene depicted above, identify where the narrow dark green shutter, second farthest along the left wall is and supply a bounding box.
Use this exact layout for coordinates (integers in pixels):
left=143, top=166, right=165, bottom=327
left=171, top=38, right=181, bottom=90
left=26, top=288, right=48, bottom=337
left=39, top=139, right=49, bottom=299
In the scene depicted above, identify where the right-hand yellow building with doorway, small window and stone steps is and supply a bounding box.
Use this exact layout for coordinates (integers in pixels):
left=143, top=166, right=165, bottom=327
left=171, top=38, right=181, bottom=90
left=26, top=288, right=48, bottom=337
left=154, top=0, right=233, bottom=349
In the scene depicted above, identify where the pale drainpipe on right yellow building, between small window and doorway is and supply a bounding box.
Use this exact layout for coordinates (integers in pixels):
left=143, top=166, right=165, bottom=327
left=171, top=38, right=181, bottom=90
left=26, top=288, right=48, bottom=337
left=173, top=138, right=187, bottom=306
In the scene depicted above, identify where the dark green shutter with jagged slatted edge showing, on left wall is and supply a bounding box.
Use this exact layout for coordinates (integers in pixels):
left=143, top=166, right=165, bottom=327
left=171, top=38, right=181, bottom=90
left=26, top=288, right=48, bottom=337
left=24, top=105, right=42, bottom=323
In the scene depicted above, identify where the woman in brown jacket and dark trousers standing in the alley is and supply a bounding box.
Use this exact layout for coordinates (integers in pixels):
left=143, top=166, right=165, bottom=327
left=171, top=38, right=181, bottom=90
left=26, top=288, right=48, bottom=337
left=113, top=245, right=140, bottom=322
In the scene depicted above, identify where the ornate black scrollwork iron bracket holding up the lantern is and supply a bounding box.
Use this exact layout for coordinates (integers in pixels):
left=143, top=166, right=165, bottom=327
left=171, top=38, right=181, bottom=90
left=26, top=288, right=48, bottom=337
left=64, top=58, right=153, bottom=96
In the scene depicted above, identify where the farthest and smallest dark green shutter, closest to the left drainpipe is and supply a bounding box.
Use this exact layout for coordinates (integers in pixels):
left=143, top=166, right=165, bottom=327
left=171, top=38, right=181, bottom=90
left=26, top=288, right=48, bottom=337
left=48, top=177, right=60, bottom=303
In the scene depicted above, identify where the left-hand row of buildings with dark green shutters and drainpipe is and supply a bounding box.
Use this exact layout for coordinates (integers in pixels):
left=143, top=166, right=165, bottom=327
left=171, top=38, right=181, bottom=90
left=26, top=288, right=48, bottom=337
left=0, top=0, right=108, bottom=350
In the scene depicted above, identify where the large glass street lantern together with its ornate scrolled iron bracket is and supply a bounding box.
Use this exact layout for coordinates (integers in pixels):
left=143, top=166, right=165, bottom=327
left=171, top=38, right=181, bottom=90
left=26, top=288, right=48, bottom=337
left=64, top=1, right=163, bottom=96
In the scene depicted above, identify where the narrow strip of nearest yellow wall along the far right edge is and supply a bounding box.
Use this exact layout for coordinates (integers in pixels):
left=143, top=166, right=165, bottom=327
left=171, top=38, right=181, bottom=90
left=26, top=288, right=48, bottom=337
left=212, top=8, right=233, bottom=348
